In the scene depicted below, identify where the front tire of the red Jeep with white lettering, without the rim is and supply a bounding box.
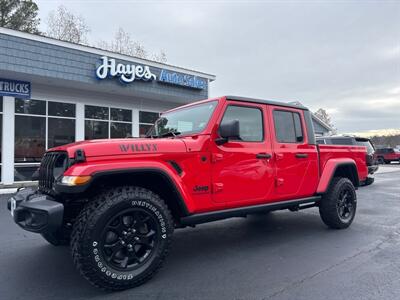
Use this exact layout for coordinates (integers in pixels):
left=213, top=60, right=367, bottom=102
left=71, top=186, right=174, bottom=291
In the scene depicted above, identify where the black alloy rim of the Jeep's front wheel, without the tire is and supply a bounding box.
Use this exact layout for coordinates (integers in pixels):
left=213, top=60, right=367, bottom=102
left=101, top=208, right=159, bottom=271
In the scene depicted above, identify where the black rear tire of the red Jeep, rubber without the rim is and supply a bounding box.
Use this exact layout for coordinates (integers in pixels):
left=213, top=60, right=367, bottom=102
left=319, top=177, right=357, bottom=229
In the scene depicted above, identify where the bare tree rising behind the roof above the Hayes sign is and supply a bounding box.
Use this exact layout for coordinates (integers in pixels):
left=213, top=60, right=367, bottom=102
left=97, top=27, right=167, bottom=62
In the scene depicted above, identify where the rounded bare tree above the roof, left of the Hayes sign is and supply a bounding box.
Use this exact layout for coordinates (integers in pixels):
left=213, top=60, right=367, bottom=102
left=46, top=5, right=90, bottom=44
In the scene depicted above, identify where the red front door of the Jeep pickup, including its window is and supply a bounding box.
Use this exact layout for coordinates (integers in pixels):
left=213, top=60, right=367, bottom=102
left=212, top=101, right=273, bottom=207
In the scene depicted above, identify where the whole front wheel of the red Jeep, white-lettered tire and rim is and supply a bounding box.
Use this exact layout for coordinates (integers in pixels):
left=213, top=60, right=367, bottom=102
left=71, top=186, right=174, bottom=290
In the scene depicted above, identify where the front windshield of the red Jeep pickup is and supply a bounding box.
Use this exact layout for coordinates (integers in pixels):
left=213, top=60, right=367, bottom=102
left=147, top=101, right=218, bottom=137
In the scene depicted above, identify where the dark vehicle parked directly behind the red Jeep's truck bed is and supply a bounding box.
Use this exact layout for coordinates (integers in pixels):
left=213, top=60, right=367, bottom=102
left=317, top=136, right=379, bottom=185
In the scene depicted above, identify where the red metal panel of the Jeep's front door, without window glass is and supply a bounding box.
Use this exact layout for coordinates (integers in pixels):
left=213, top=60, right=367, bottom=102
left=212, top=102, right=274, bottom=207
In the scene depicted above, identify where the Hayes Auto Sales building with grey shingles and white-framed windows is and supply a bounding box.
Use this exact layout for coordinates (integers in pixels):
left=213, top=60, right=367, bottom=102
left=0, top=28, right=329, bottom=186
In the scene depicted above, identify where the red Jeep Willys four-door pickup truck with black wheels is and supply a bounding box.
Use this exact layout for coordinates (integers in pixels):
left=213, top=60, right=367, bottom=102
left=8, top=96, right=368, bottom=290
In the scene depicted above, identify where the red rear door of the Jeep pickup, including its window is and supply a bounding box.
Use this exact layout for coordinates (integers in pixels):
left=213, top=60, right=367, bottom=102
left=269, top=106, right=319, bottom=200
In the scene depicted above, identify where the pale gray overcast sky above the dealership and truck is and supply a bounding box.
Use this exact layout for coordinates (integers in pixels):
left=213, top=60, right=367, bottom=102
left=36, top=0, right=400, bottom=132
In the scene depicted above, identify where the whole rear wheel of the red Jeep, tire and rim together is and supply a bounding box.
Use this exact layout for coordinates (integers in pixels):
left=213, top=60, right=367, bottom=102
left=319, top=177, right=357, bottom=229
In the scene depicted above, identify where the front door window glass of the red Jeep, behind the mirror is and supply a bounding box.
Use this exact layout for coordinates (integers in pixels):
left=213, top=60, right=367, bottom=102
left=221, top=105, right=264, bottom=142
